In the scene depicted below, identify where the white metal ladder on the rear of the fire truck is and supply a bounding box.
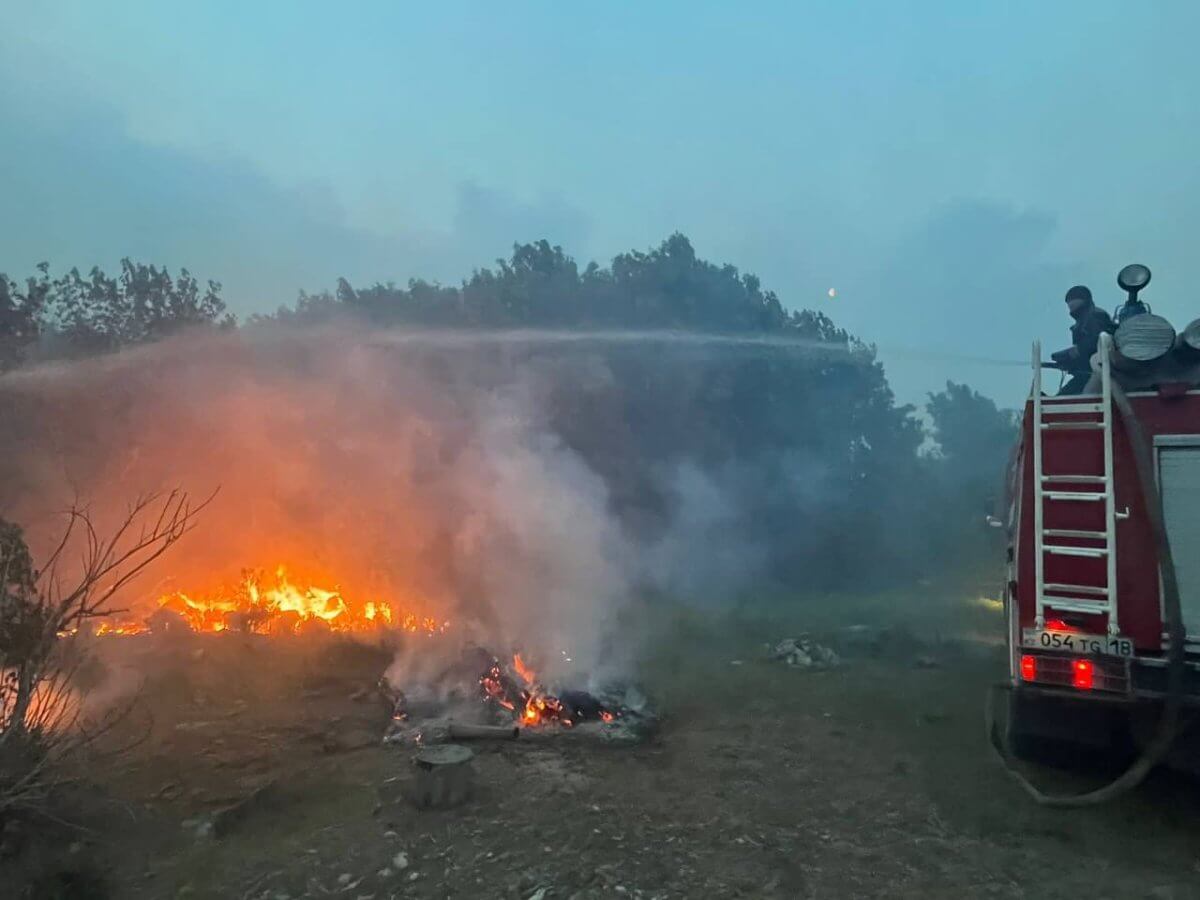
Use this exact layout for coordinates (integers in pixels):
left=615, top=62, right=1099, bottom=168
left=1033, top=335, right=1129, bottom=636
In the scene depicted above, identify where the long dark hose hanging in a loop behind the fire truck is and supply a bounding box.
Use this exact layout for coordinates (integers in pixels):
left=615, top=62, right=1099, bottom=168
left=984, top=384, right=1184, bottom=809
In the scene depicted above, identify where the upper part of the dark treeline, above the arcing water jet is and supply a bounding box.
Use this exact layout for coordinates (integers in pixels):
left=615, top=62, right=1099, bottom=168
left=0, top=234, right=865, bottom=371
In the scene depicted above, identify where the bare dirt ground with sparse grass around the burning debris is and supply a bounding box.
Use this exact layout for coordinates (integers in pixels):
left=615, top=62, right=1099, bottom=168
left=7, top=588, right=1200, bottom=900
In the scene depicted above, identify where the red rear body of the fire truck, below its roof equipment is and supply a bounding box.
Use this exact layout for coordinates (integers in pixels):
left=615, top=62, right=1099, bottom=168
left=1006, top=336, right=1200, bottom=751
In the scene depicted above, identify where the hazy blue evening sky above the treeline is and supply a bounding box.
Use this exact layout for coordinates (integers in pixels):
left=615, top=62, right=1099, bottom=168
left=0, top=0, right=1200, bottom=402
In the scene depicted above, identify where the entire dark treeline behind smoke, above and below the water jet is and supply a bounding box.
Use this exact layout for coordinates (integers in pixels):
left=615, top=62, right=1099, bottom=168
left=0, top=234, right=1015, bottom=588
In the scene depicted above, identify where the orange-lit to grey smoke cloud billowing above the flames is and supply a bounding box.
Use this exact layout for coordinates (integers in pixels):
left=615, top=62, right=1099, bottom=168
left=0, top=326, right=772, bottom=671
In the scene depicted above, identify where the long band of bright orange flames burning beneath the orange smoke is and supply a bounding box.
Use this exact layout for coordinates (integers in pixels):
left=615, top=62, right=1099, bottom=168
left=96, top=565, right=450, bottom=635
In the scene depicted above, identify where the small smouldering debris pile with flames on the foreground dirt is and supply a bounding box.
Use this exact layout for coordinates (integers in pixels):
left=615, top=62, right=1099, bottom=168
left=380, top=647, right=656, bottom=744
